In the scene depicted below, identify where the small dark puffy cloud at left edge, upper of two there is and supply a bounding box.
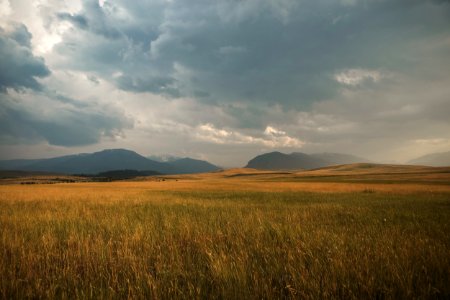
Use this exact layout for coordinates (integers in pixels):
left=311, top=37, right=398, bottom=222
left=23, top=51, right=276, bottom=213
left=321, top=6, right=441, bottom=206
left=0, top=24, right=50, bottom=92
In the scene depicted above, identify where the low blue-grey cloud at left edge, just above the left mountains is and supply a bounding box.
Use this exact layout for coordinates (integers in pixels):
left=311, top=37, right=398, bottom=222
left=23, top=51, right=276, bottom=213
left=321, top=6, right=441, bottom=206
left=0, top=93, right=132, bottom=147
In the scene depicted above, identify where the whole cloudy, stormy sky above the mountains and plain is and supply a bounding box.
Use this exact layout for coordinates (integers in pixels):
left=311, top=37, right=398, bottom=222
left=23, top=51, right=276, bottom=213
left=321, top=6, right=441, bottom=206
left=0, top=0, right=450, bottom=167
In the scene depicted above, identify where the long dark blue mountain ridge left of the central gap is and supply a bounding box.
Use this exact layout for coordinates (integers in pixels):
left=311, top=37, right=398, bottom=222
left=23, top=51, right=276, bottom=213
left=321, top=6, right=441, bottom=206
left=0, top=149, right=220, bottom=174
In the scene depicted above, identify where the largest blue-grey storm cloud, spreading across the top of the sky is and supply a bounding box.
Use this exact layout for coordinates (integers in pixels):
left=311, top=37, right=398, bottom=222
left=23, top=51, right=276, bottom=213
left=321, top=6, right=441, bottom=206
left=51, top=0, right=450, bottom=109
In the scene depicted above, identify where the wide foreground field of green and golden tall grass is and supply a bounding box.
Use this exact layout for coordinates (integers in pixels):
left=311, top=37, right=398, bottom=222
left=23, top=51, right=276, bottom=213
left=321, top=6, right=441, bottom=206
left=0, top=183, right=450, bottom=299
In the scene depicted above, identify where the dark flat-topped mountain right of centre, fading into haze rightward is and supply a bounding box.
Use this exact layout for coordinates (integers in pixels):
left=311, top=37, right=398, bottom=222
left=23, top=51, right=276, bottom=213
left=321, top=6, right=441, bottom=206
left=245, top=152, right=369, bottom=170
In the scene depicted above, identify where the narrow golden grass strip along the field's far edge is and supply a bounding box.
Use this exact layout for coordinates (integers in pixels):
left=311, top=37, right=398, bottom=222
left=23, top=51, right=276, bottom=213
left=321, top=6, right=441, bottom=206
left=1, top=178, right=450, bottom=199
